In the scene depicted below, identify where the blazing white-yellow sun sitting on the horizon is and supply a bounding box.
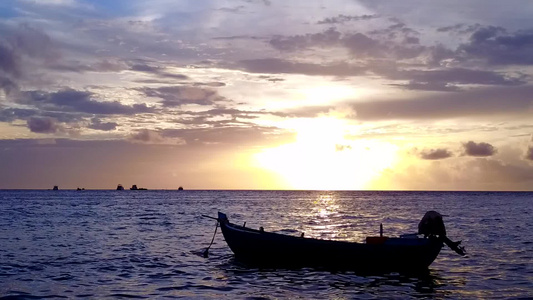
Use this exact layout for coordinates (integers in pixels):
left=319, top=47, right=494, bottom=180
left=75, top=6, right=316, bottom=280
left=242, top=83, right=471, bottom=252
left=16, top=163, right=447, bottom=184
left=255, top=117, right=397, bottom=190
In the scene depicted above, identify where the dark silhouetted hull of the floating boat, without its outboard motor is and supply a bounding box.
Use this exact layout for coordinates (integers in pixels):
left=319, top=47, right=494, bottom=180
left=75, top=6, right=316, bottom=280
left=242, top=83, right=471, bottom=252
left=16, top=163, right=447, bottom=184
left=218, top=212, right=443, bottom=271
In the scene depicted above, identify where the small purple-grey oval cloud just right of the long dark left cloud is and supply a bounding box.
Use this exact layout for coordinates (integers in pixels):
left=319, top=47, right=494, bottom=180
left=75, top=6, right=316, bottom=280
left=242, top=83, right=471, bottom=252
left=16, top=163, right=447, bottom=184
left=137, top=86, right=227, bottom=107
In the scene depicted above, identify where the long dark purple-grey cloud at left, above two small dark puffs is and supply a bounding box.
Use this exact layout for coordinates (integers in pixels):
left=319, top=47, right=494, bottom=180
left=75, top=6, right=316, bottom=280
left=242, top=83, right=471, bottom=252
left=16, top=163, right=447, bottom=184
left=17, top=88, right=154, bottom=115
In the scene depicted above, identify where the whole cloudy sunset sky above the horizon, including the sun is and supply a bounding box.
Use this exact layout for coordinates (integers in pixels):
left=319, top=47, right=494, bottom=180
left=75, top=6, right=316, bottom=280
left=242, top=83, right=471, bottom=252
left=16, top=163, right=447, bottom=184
left=0, top=0, right=533, bottom=190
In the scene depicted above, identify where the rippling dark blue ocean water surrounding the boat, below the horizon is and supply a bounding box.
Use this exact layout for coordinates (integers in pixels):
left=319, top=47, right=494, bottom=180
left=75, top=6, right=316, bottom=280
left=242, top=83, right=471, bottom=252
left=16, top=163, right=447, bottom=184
left=0, top=190, right=533, bottom=299
